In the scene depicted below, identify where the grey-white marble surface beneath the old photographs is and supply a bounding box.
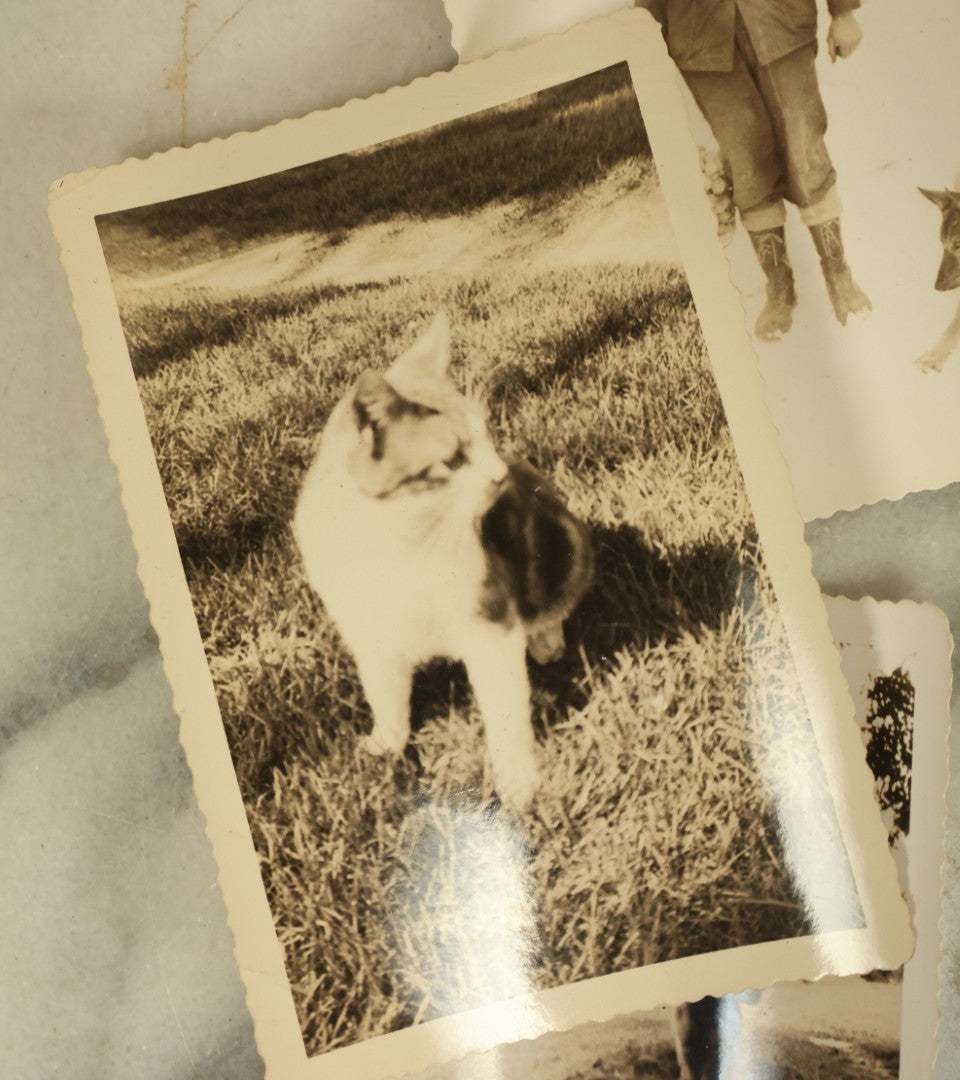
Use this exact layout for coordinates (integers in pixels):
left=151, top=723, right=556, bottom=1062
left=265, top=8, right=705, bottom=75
left=0, top=0, right=960, bottom=1080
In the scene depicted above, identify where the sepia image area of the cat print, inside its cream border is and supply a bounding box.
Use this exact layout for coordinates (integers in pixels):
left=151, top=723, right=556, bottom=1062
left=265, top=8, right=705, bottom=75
left=97, top=64, right=864, bottom=1055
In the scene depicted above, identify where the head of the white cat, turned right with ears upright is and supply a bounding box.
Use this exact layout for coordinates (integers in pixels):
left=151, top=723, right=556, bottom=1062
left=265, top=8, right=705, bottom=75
left=348, top=315, right=506, bottom=499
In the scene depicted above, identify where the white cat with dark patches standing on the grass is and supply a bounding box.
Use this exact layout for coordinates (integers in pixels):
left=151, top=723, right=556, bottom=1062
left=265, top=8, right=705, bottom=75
left=294, top=315, right=593, bottom=810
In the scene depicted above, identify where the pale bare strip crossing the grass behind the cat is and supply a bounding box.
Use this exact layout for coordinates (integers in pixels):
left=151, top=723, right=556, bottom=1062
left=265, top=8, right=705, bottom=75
left=117, top=170, right=679, bottom=299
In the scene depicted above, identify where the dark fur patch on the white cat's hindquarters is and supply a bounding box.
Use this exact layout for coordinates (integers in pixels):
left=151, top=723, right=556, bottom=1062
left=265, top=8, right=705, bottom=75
left=479, top=463, right=593, bottom=623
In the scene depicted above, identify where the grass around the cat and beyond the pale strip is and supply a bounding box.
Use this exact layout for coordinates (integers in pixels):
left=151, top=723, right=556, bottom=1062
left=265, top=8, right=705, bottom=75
left=95, top=61, right=855, bottom=1053
